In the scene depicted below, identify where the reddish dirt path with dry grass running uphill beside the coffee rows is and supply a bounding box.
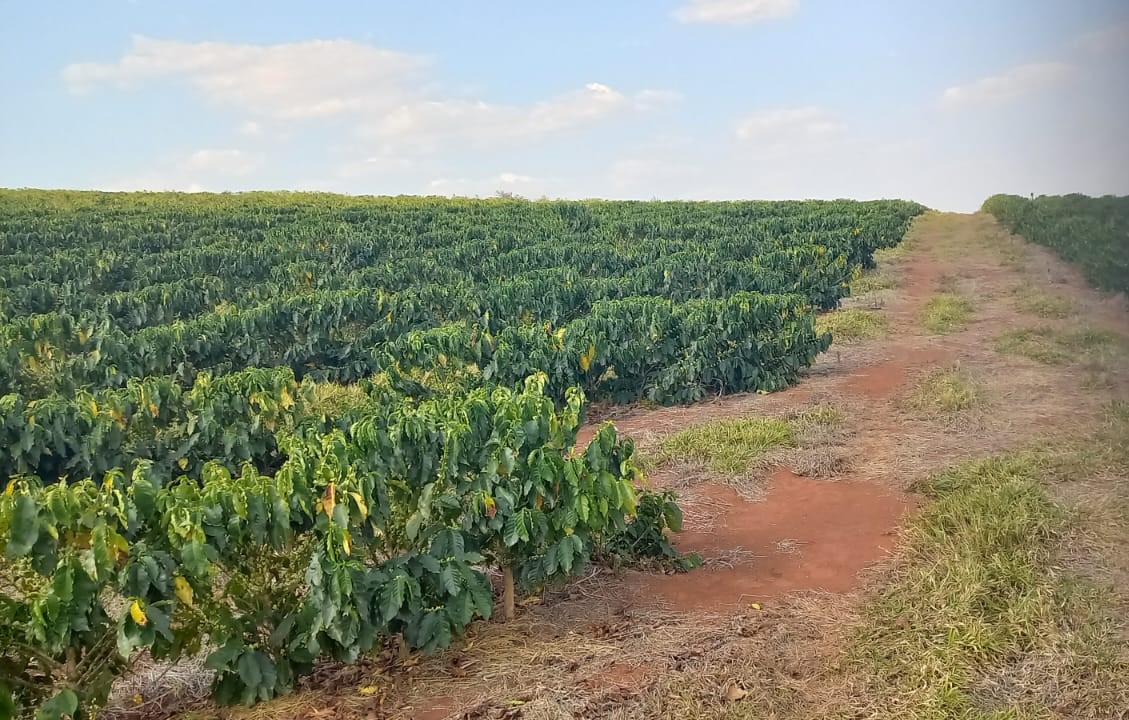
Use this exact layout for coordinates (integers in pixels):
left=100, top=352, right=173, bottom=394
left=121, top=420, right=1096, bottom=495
left=187, top=213, right=1129, bottom=720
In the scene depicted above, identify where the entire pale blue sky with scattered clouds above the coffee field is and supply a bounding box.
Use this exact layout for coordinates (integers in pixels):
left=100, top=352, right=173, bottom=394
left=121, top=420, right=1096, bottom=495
left=0, top=0, right=1129, bottom=211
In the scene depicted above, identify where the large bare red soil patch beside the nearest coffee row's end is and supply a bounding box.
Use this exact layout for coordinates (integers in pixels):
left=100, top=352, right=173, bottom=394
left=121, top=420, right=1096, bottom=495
left=625, top=468, right=916, bottom=611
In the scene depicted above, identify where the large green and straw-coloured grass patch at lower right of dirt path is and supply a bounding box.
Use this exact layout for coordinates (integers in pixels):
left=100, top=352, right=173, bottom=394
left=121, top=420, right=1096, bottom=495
left=849, top=404, right=1129, bottom=720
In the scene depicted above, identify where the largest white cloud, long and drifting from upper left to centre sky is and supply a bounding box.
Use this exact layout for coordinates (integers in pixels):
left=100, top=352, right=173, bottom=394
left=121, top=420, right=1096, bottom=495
left=62, top=36, right=680, bottom=165
